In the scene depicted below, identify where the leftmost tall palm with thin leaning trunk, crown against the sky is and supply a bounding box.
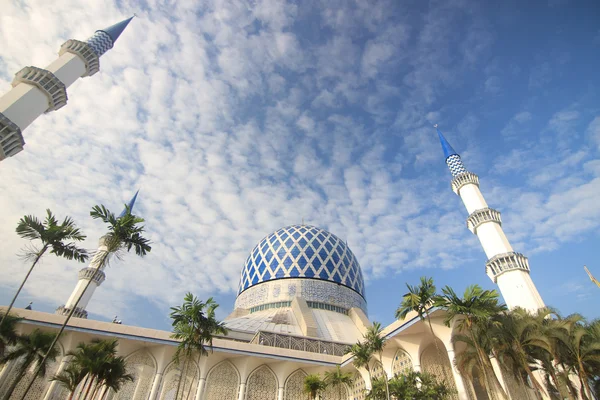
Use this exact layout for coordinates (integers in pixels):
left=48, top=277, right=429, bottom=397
left=0, top=209, right=88, bottom=326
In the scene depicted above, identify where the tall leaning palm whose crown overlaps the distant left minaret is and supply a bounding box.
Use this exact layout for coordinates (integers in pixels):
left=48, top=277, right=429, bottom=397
left=21, top=204, right=152, bottom=400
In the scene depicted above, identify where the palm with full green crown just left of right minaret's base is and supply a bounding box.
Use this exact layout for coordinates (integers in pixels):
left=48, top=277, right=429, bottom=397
left=434, top=285, right=507, bottom=399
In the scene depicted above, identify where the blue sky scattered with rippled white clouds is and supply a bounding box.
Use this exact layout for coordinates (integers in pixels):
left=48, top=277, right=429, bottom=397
left=0, top=0, right=600, bottom=329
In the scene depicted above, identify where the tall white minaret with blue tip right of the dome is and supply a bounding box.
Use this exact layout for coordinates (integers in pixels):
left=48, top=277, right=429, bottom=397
left=435, top=125, right=544, bottom=312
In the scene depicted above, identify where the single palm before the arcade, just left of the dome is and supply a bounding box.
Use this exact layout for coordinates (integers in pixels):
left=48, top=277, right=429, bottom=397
left=170, top=293, right=227, bottom=400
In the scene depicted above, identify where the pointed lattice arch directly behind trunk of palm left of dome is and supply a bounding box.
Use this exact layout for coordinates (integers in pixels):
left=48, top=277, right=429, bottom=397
left=159, top=358, right=200, bottom=400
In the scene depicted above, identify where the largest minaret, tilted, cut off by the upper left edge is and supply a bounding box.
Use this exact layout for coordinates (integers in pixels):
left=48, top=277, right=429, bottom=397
left=0, top=17, right=133, bottom=161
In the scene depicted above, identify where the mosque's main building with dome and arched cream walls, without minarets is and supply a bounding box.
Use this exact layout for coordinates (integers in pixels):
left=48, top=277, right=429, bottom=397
left=0, top=225, right=527, bottom=400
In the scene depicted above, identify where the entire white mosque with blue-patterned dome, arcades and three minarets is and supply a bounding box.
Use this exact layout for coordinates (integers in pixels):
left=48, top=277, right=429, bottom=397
left=0, top=18, right=544, bottom=400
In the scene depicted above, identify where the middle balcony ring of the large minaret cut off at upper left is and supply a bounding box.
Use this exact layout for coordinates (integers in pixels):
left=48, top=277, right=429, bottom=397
left=12, top=67, right=67, bottom=112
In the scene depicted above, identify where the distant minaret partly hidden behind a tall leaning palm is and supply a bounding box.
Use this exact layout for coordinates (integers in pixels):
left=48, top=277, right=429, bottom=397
left=56, top=190, right=139, bottom=318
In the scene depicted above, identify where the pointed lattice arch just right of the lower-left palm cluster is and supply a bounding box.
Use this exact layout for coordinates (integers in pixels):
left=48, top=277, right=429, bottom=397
left=113, top=348, right=157, bottom=400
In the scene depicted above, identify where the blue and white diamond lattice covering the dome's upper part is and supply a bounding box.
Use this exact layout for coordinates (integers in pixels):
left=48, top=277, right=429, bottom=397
left=238, top=225, right=365, bottom=298
